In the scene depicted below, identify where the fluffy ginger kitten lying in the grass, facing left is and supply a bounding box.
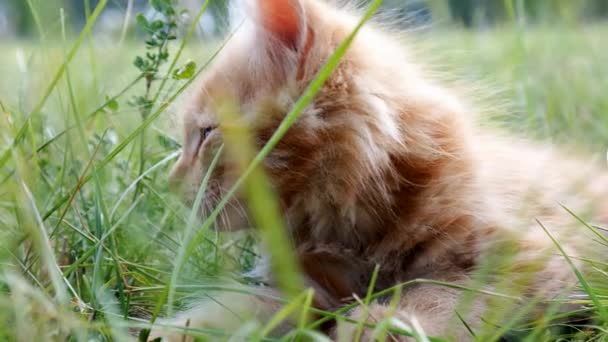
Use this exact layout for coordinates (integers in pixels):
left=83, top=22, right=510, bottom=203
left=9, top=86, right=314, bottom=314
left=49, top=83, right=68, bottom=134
left=154, top=0, right=608, bottom=341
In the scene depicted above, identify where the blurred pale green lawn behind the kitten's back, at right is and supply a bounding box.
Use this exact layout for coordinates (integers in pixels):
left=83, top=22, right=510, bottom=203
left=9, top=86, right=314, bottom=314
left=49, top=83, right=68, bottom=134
left=424, top=24, right=608, bottom=148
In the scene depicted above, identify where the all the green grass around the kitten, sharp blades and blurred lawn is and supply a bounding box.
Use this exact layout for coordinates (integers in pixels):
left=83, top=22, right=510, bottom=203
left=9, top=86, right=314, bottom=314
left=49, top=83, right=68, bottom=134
left=0, top=3, right=608, bottom=341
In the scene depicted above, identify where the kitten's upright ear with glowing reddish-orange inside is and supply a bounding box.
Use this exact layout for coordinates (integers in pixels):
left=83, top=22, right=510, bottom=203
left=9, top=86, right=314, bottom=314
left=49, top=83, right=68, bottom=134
left=254, top=0, right=307, bottom=50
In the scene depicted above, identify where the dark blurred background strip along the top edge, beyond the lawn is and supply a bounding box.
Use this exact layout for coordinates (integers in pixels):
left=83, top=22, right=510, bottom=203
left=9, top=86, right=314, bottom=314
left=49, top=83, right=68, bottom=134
left=0, top=0, right=608, bottom=37
